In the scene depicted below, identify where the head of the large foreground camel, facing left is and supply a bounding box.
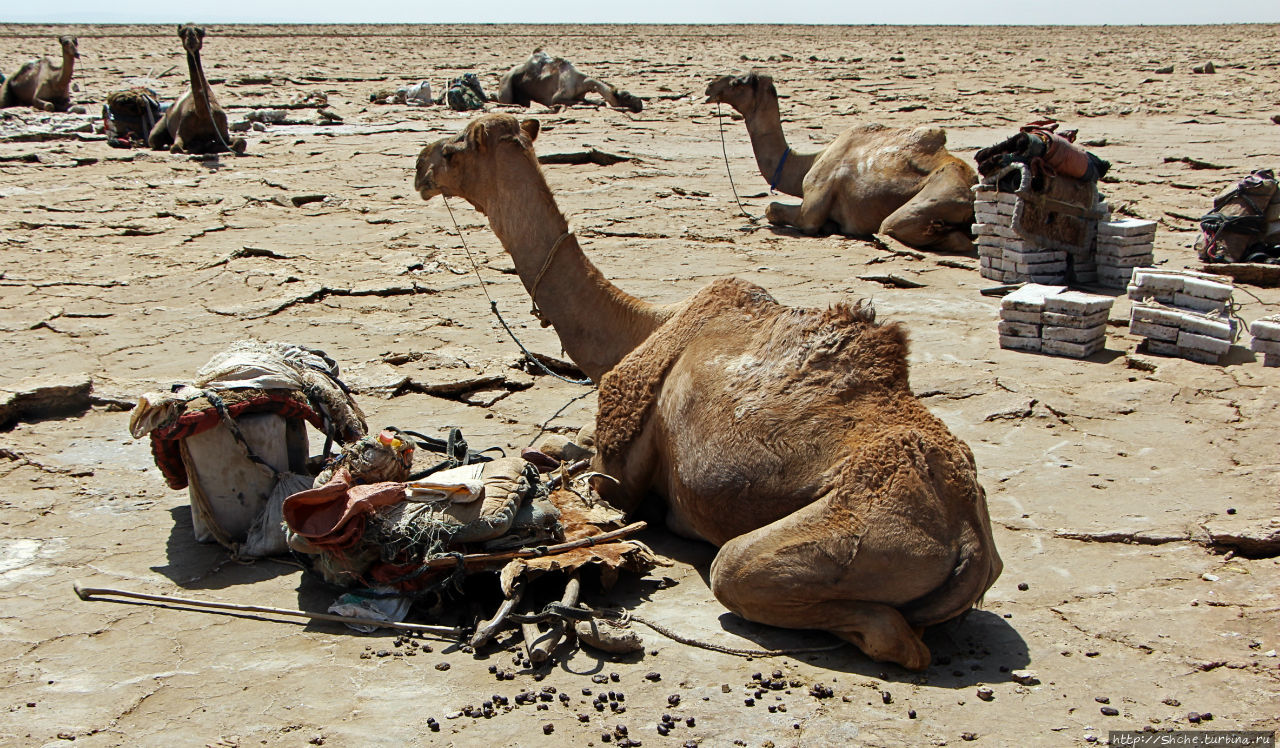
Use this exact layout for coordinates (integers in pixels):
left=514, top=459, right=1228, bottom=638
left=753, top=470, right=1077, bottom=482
left=413, top=114, right=539, bottom=213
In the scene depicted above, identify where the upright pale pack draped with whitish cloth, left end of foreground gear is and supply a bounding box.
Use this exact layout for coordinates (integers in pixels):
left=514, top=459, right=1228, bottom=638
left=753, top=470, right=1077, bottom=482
left=129, top=341, right=367, bottom=557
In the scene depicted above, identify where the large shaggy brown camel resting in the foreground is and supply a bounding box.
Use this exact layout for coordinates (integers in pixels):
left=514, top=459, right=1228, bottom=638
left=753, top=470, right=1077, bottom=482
left=413, top=114, right=1001, bottom=670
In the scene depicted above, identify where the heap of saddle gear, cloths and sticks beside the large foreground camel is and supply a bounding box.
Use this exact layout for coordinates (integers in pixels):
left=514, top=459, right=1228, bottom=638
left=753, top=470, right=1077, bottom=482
left=129, top=341, right=659, bottom=661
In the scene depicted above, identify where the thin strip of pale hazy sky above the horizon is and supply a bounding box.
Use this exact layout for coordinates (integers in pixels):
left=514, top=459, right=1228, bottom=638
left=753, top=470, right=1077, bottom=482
left=10, top=0, right=1280, bottom=24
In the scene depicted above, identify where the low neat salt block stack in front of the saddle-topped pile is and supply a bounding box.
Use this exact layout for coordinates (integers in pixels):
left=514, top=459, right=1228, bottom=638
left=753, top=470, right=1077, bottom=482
left=1000, top=283, right=1115, bottom=359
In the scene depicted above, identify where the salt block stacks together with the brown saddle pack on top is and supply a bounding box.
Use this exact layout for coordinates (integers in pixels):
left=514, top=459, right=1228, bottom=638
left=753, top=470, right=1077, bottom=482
left=973, top=120, right=1156, bottom=288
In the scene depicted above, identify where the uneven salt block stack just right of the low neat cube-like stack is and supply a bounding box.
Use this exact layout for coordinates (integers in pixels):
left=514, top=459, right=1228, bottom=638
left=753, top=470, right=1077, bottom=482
left=1129, top=268, right=1228, bottom=364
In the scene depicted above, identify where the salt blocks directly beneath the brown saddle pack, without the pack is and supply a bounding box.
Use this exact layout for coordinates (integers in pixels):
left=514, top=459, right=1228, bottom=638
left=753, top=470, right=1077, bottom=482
left=973, top=184, right=1066, bottom=283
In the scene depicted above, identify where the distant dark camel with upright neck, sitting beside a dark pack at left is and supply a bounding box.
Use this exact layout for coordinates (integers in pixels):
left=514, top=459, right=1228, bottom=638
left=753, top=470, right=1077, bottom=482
left=147, top=23, right=244, bottom=154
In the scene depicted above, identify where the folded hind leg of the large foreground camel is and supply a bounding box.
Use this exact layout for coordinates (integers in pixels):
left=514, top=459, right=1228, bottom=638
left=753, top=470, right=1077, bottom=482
left=710, top=502, right=938, bottom=670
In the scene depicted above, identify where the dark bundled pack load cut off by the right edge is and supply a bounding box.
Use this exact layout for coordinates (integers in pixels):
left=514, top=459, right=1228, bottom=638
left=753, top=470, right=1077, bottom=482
left=1196, top=169, right=1280, bottom=264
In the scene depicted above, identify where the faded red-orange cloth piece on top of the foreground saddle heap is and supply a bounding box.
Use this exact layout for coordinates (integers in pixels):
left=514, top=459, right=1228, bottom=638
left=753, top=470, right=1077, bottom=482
left=283, top=468, right=404, bottom=551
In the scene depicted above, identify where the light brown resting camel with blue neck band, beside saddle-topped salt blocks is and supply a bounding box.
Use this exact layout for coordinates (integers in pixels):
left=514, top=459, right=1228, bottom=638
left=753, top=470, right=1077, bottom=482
left=707, top=73, right=978, bottom=252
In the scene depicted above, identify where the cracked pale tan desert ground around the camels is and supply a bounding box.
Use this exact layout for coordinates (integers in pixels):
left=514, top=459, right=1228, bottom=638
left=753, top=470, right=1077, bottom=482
left=0, top=26, right=1280, bottom=747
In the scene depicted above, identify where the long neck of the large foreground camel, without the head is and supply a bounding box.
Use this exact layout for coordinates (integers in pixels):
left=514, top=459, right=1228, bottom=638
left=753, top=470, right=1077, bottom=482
left=485, top=160, right=664, bottom=383
